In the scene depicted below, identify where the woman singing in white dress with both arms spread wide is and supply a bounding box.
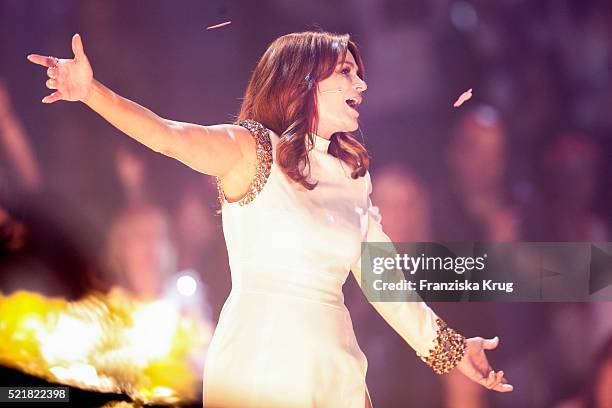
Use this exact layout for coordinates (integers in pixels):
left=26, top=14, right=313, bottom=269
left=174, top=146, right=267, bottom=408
left=28, top=32, right=512, bottom=408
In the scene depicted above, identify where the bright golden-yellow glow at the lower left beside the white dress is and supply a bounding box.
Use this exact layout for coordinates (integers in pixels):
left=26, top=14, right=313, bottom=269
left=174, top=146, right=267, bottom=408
left=0, top=289, right=213, bottom=404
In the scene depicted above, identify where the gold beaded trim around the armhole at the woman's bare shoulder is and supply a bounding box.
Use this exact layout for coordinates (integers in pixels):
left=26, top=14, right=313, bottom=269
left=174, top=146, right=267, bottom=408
left=216, top=119, right=272, bottom=206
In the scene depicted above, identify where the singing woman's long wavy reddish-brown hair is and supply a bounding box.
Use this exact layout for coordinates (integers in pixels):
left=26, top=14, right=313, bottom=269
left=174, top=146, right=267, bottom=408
left=238, top=31, right=369, bottom=190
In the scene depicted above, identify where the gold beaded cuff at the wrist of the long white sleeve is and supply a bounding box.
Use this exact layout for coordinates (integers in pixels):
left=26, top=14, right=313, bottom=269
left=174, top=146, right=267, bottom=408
left=419, top=319, right=466, bottom=374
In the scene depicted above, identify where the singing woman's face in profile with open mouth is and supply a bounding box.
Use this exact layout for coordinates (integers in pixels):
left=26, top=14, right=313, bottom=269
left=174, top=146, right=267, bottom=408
left=316, top=51, right=367, bottom=139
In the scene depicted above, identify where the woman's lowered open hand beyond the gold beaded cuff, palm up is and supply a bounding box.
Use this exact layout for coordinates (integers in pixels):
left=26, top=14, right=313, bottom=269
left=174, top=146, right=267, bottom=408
left=456, top=337, right=514, bottom=392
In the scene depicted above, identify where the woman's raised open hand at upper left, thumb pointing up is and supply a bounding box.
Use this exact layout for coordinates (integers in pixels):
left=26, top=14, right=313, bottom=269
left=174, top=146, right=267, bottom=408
left=27, top=34, right=93, bottom=103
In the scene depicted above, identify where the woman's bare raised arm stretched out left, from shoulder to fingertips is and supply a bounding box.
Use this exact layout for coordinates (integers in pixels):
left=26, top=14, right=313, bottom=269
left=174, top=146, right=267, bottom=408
left=28, top=34, right=255, bottom=179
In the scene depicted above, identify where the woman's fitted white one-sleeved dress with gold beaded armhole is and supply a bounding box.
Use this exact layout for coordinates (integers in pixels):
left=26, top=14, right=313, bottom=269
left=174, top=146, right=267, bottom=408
left=203, top=121, right=464, bottom=408
